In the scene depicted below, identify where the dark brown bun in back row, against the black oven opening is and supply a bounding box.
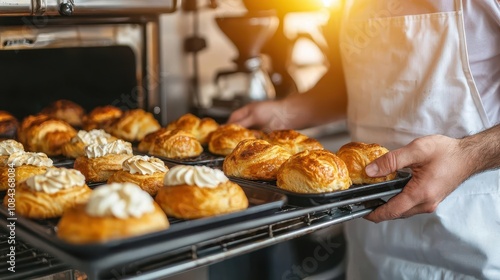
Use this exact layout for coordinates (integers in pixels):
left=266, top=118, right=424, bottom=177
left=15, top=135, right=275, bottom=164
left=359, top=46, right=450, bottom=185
left=40, top=99, right=85, bottom=127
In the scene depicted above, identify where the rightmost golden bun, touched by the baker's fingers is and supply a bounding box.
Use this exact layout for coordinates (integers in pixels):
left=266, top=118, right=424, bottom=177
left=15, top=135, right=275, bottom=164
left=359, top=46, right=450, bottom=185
left=337, top=142, right=397, bottom=184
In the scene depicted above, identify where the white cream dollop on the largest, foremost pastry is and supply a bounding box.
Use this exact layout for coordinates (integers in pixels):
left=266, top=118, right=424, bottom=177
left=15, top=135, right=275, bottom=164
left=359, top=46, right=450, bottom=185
left=85, top=183, right=155, bottom=219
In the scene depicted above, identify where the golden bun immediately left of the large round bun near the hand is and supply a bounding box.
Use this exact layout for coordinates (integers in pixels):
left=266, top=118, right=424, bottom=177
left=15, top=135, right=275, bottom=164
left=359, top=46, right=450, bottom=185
left=222, top=139, right=292, bottom=180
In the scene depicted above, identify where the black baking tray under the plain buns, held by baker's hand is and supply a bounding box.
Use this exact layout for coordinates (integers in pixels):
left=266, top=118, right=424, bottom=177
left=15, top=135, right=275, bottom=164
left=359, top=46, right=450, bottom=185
left=231, top=170, right=411, bottom=207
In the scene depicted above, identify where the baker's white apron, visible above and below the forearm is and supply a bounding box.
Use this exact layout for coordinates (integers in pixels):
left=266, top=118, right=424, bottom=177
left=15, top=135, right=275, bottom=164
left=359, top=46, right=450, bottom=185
left=340, top=0, right=500, bottom=280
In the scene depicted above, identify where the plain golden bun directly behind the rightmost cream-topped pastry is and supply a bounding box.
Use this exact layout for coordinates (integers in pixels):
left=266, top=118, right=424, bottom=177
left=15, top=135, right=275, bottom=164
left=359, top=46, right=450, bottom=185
left=138, top=128, right=203, bottom=159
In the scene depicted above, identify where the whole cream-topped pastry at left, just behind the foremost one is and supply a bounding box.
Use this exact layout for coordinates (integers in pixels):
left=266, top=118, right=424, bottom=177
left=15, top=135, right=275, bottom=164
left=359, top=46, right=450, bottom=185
left=4, top=168, right=92, bottom=219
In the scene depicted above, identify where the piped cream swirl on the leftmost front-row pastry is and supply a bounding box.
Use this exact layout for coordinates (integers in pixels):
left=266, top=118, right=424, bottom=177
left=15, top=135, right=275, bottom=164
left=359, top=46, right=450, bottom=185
left=26, top=168, right=85, bottom=194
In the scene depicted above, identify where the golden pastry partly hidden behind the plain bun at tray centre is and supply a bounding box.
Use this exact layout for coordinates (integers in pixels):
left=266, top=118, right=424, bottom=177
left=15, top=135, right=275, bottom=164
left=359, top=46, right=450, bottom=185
left=167, top=114, right=219, bottom=144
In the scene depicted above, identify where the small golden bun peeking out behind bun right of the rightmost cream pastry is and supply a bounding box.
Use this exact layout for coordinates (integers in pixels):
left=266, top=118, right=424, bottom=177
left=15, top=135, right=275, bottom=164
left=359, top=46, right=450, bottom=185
left=208, top=124, right=256, bottom=156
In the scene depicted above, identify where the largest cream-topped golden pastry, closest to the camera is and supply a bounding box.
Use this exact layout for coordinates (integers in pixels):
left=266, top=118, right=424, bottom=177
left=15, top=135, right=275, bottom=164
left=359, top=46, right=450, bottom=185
left=57, top=183, right=170, bottom=244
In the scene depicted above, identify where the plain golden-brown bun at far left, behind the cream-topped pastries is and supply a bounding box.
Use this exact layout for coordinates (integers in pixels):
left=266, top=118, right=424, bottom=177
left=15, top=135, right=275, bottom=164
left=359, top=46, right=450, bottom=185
left=18, top=115, right=76, bottom=156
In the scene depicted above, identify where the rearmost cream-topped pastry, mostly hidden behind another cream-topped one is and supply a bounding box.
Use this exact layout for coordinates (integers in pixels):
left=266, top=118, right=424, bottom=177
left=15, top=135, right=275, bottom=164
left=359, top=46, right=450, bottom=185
left=61, top=129, right=116, bottom=158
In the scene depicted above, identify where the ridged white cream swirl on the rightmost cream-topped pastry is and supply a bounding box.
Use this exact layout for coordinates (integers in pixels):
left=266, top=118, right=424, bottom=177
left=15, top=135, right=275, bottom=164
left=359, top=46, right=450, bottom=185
left=164, top=165, right=229, bottom=188
